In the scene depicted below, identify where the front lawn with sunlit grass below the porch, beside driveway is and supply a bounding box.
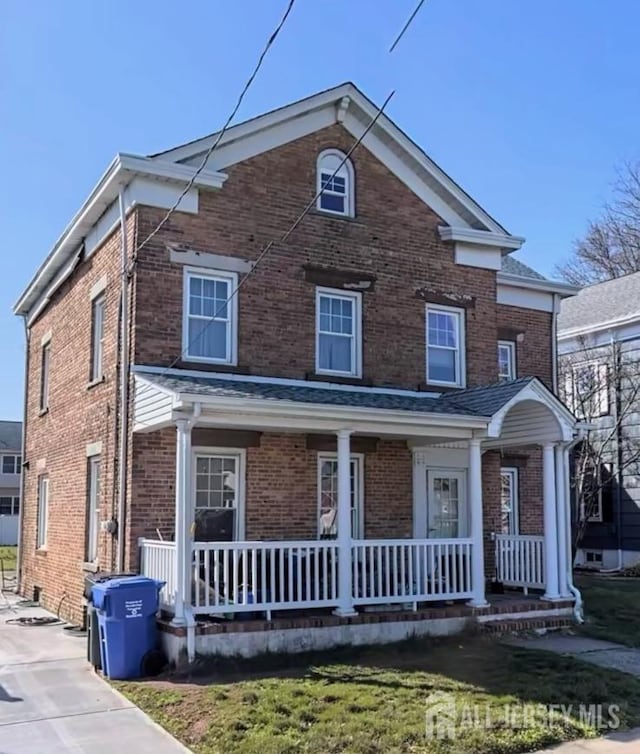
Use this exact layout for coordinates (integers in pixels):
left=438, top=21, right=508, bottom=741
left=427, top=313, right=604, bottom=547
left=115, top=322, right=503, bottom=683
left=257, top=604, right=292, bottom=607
left=116, top=636, right=640, bottom=754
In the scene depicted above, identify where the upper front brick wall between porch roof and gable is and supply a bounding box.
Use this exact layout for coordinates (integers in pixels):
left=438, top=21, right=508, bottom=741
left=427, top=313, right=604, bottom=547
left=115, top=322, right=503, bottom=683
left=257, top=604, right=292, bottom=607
left=135, top=126, right=497, bottom=388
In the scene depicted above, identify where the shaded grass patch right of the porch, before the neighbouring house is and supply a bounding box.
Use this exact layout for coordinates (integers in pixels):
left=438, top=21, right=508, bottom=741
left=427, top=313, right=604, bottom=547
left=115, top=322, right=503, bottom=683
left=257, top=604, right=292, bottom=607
left=576, top=575, right=640, bottom=647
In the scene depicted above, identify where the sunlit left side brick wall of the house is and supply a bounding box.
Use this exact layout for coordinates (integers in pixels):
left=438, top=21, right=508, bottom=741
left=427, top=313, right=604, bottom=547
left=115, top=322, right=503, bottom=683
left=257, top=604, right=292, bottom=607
left=20, top=213, right=135, bottom=621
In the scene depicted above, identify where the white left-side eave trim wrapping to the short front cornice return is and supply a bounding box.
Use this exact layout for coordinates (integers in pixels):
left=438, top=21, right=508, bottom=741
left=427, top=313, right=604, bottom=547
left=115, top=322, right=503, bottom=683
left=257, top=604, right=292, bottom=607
left=13, top=153, right=227, bottom=315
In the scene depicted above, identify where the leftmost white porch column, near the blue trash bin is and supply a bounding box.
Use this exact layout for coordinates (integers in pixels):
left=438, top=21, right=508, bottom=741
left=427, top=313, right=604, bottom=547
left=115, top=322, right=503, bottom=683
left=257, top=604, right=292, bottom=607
left=172, top=419, right=191, bottom=626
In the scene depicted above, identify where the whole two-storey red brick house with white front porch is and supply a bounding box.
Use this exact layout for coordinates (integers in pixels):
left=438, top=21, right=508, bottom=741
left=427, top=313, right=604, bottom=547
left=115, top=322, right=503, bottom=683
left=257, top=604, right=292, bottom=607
left=15, top=84, right=575, bottom=656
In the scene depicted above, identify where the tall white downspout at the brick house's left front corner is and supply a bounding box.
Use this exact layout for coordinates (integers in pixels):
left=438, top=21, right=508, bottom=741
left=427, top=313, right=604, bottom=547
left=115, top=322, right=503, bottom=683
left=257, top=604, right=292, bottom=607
left=117, top=186, right=129, bottom=573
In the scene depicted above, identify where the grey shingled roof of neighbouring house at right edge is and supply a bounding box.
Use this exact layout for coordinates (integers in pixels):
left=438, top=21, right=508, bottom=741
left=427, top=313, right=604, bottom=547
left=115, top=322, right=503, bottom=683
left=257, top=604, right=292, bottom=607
left=558, top=272, right=640, bottom=336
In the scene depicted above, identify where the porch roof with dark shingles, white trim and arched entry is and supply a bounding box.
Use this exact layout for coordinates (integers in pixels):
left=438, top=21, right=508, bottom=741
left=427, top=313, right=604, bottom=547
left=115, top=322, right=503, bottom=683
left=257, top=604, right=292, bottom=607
left=134, top=366, right=575, bottom=439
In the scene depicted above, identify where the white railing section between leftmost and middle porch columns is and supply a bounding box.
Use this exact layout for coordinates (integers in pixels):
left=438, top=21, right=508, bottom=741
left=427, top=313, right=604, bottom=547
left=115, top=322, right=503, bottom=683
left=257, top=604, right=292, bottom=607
left=191, top=541, right=338, bottom=616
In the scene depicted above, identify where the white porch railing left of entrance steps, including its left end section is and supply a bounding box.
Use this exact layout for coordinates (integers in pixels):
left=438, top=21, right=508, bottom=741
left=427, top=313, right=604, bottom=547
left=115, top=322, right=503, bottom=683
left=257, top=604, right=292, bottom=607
left=139, top=539, right=473, bottom=617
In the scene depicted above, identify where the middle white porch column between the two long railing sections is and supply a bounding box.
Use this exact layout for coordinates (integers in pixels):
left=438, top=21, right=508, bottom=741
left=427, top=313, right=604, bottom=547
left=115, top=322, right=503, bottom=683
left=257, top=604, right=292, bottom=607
left=334, top=429, right=356, bottom=617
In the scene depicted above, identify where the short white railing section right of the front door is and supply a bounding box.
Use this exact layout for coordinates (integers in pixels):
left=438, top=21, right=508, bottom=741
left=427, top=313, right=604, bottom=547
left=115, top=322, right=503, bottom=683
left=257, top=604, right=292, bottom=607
left=495, top=534, right=545, bottom=589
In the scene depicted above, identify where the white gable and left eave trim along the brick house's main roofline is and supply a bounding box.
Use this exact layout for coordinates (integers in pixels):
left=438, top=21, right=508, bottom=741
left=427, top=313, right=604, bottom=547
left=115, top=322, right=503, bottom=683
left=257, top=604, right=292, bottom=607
left=14, top=82, right=524, bottom=320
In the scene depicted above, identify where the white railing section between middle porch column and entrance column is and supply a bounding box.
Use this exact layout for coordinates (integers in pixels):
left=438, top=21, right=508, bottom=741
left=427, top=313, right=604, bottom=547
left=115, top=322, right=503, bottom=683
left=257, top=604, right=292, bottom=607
left=351, top=539, right=472, bottom=605
